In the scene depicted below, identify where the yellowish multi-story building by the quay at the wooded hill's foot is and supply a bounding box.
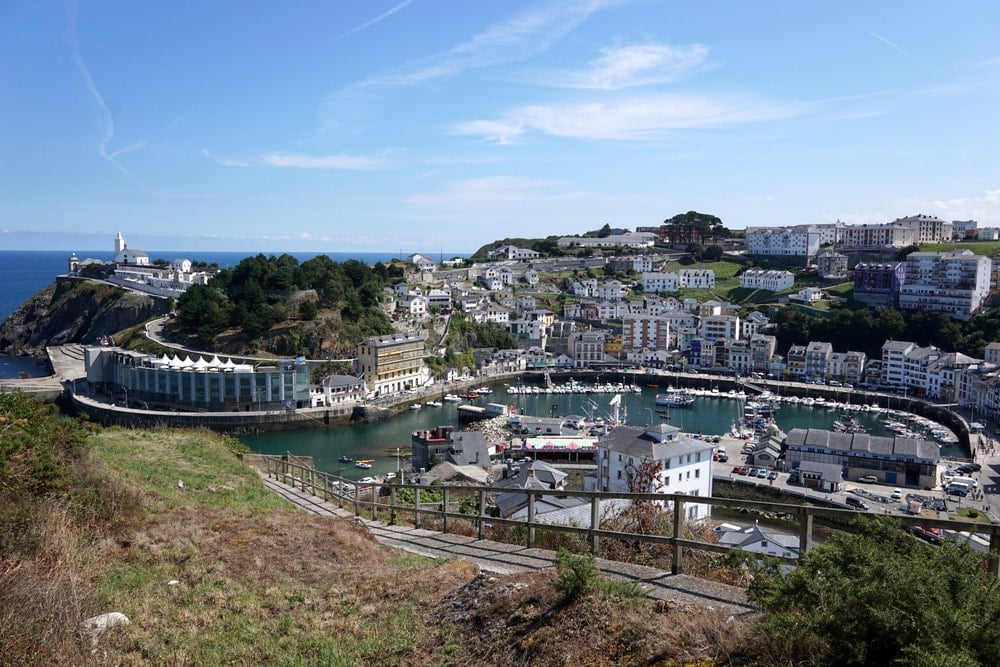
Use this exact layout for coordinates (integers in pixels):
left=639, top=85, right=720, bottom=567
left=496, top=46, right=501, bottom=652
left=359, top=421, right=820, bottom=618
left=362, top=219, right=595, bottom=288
left=358, top=333, right=429, bottom=396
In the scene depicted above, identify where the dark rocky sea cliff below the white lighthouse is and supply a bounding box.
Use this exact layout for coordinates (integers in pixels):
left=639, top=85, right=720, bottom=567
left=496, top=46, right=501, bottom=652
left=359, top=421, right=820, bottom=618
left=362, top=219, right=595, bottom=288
left=0, top=278, right=169, bottom=357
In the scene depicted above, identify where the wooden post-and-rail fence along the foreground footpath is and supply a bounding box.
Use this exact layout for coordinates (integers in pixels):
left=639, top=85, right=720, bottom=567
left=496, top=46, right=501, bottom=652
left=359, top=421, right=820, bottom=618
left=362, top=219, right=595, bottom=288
left=263, top=456, right=1000, bottom=575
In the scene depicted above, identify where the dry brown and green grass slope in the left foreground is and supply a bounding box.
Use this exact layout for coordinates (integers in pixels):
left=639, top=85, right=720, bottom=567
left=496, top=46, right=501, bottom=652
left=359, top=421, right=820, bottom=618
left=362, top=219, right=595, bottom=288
left=0, top=420, right=764, bottom=665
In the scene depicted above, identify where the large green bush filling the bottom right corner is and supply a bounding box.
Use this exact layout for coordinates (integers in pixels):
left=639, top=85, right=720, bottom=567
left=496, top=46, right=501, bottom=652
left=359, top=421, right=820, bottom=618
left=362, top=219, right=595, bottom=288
left=748, top=517, right=1000, bottom=665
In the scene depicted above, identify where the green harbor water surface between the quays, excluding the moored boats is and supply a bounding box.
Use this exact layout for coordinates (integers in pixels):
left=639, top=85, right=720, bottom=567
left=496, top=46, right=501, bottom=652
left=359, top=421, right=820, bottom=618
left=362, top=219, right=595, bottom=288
left=240, top=385, right=960, bottom=479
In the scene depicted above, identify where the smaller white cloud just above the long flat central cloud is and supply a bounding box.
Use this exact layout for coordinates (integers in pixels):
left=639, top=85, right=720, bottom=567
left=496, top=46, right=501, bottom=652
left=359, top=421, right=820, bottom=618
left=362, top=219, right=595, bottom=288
left=544, top=44, right=709, bottom=90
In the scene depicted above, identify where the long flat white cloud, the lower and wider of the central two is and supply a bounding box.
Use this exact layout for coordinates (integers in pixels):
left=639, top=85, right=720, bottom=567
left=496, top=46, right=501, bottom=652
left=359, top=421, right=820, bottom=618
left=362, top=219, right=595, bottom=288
left=454, top=93, right=801, bottom=143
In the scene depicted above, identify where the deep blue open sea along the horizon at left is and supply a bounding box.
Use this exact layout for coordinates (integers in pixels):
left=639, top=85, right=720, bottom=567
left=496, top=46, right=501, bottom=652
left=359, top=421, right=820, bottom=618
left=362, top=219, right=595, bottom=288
left=0, top=249, right=460, bottom=378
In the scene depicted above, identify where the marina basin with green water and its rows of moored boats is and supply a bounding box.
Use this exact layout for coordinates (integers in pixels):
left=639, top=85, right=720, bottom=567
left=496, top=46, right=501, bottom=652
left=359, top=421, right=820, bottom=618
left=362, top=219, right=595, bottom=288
left=240, top=383, right=964, bottom=479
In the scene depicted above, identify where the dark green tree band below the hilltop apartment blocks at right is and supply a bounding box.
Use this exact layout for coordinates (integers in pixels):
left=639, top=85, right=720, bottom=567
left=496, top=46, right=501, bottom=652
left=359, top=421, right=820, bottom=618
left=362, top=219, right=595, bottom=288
left=775, top=304, right=1000, bottom=358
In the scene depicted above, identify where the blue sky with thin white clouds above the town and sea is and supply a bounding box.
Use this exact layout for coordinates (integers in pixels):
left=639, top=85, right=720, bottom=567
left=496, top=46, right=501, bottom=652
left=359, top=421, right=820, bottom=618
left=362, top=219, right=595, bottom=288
left=0, top=0, right=1000, bottom=253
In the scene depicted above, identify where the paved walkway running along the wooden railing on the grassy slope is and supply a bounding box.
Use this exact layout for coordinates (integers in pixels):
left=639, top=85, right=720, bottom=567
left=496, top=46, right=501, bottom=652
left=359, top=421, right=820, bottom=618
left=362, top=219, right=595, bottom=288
left=262, top=476, right=755, bottom=616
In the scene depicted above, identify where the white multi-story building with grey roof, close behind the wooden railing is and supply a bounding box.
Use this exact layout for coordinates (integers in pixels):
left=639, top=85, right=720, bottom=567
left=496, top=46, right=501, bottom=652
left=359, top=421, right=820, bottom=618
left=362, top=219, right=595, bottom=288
left=584, top=424, right=712, bottom=521
